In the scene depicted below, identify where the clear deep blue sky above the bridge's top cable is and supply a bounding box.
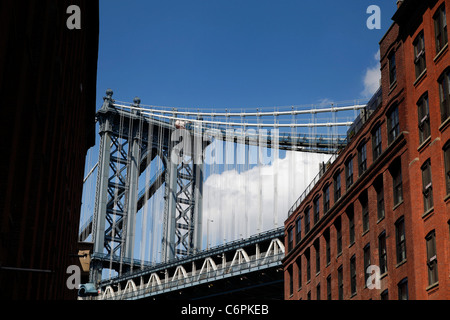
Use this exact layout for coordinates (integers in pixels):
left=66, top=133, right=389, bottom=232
left=97, top=0, right=396, bottom=110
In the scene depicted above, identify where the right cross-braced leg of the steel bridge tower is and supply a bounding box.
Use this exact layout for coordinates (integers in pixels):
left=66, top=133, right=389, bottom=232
left=162, top=114, right=203, bottom=262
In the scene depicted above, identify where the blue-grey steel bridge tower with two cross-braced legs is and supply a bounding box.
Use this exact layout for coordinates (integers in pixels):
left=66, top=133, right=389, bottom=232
left=90, top=89, right=205, bottom=283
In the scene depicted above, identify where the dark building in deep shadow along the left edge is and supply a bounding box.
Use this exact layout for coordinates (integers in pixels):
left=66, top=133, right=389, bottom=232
left=0, top=0, right=99, bottom=300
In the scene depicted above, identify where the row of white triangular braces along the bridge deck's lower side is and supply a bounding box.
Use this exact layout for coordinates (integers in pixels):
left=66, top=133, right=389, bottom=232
left=96, top=252, right=284, bottom=300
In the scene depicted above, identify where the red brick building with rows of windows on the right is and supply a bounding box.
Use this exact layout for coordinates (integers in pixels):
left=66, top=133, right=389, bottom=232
left=283, top=0, right=450, bottom=300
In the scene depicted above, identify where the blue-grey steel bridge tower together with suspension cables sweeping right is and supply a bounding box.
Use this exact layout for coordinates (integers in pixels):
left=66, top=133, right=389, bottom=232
left=86, top=90, right=365, bottom=283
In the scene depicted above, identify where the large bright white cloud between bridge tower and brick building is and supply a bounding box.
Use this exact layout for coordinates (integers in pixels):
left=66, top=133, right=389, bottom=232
left=202, top=152, right=330, bottom=248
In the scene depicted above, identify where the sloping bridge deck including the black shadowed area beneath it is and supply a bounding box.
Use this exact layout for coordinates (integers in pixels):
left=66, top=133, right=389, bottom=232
left=85, top=228, right=285, bottom=300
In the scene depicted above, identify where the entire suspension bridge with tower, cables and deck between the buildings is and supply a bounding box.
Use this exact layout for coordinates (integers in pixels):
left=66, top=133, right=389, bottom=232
left=79, top=89, right=381, bottom=300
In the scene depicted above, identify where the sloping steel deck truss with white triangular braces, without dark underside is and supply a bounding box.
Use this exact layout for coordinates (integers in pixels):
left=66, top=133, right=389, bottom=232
left=82, top=228, right=285, bottom=300
